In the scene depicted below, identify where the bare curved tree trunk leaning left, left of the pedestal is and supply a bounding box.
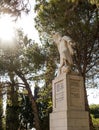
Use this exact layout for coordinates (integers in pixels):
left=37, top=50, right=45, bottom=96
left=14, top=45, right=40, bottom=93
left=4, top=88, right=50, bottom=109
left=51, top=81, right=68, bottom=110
left=15, top=71, right=41, bottom=130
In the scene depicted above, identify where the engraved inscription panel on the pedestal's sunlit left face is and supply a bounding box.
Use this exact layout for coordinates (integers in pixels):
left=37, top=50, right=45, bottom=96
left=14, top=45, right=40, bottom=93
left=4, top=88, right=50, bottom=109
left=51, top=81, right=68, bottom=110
left=54, top=81, right=64, bottom=108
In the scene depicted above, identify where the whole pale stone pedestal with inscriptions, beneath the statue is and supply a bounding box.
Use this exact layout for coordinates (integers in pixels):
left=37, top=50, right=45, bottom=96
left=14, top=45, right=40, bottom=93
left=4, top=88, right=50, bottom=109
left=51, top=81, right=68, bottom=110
left=50, top=73, right=89, bottom=130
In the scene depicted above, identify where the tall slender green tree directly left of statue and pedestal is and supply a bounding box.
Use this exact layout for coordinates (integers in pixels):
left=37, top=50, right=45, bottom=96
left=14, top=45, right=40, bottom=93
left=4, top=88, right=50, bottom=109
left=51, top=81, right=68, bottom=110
left=34, top=41, right=58, bottom=130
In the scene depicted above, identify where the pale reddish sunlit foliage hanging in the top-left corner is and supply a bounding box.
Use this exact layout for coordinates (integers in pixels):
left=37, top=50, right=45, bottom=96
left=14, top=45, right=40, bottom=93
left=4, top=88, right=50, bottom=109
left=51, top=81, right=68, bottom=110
left=0, top=0, right=30, bottom=17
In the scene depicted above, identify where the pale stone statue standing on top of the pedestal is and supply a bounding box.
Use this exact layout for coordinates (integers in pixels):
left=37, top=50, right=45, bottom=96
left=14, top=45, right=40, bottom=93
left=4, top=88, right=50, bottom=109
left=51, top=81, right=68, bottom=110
left=53, top=33, right=74, bottom=74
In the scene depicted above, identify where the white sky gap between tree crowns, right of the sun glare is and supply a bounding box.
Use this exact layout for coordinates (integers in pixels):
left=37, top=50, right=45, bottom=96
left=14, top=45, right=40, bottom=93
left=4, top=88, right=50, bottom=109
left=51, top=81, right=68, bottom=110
left=17, top=0, right=40, bottom=43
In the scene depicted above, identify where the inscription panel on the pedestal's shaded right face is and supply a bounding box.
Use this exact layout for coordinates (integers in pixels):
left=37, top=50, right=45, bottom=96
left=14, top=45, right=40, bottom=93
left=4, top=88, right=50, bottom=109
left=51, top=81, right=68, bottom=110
left=70, top=80, right=81, bottom=106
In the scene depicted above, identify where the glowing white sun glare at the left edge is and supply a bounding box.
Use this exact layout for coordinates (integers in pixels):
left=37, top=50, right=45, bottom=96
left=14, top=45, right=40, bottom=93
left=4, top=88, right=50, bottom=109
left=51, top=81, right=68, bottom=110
left=0, top=14, right=15, bottom=43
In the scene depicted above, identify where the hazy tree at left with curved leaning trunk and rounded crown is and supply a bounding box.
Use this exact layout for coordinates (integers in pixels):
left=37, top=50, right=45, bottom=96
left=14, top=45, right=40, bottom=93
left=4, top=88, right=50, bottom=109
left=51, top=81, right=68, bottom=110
left=0, top=31, right=44, bottom=130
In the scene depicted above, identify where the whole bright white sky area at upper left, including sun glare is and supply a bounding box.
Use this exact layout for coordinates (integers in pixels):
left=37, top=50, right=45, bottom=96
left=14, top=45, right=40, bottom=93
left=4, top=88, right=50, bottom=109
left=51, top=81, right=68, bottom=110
left=0, top=1, right=40, bottom=45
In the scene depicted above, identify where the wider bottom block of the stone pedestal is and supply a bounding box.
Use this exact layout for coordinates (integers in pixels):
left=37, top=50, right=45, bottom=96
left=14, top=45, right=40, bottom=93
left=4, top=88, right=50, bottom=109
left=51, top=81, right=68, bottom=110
left=50, top=111, right=89, bottom=130
